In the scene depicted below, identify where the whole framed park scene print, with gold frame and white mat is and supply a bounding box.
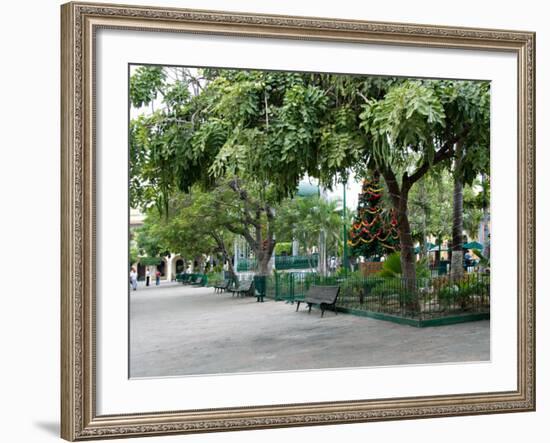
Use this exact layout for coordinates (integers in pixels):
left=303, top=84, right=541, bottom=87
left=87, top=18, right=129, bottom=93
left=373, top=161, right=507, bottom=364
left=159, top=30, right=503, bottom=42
left=61, top=2, right=535, bottom=441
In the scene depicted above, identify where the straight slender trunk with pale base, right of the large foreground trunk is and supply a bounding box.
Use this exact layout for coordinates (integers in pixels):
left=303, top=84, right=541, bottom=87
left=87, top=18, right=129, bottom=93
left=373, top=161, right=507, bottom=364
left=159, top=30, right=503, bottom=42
left=451, top=145, right=464, bottom=280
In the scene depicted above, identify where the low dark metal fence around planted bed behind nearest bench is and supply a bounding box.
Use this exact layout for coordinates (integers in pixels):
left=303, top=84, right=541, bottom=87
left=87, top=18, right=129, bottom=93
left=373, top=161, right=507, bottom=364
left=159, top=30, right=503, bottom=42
left=265, top=273, right=490, bottom=319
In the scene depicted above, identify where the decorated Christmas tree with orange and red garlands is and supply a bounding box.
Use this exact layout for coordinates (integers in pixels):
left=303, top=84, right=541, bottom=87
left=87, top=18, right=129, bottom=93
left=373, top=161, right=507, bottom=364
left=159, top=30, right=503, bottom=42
left=348, top=174, right=399, bottom=259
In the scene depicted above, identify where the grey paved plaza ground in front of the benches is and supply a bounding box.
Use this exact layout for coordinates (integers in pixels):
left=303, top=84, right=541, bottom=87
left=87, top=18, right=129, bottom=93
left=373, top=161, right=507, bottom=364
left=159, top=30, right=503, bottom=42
left=130, top=283, right=490, bottom=377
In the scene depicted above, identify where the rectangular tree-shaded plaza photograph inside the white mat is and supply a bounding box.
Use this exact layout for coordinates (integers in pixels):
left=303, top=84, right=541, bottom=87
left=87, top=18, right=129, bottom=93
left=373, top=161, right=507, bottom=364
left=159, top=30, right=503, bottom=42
left=128, top=64, right=492, bottom=378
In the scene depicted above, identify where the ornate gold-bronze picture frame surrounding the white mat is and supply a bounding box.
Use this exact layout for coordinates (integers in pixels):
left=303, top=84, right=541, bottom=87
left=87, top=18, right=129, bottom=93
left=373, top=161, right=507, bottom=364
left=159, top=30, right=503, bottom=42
left=61, top=2, right=535, bottom=441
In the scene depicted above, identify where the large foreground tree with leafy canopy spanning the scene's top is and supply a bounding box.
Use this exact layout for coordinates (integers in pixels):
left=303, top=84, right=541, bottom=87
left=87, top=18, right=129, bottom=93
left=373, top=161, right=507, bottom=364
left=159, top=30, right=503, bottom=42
left=131, top=65, right=488, bottom=288
